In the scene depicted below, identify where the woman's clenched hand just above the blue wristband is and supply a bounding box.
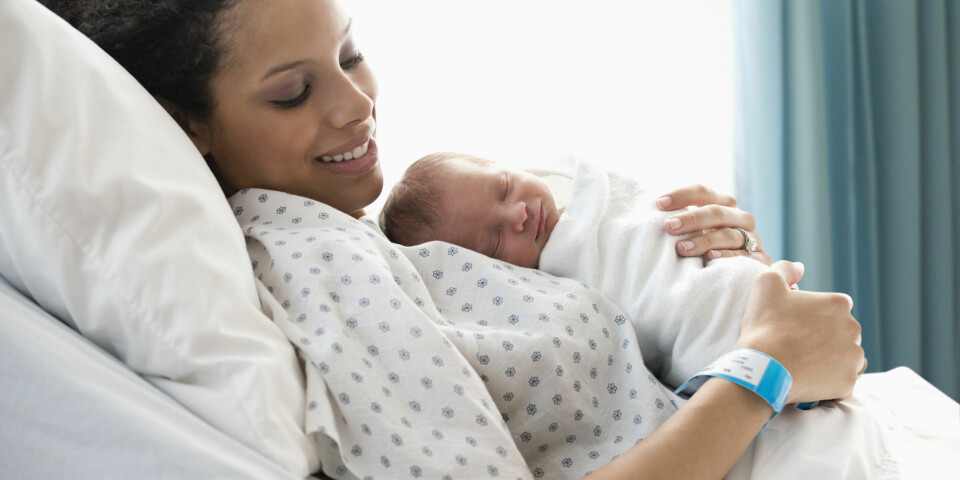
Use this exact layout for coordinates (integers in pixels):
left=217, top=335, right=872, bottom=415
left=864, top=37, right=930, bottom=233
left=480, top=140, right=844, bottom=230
left=735, top=262, right=865, bottom=403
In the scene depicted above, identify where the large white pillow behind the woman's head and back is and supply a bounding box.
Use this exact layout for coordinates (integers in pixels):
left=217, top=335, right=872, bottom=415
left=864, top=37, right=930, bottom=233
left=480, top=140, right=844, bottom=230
left=0, top=0, right=316, bottom=475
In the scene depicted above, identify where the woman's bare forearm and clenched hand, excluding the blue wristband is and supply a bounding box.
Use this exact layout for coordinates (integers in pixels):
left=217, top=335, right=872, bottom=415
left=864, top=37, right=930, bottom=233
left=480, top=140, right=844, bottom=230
left=590, top=262, right=863, bottom=479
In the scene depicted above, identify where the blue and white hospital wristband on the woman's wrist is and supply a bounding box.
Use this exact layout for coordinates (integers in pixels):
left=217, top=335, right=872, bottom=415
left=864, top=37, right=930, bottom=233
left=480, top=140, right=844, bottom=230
left=674, top=349, right=793, bottom=418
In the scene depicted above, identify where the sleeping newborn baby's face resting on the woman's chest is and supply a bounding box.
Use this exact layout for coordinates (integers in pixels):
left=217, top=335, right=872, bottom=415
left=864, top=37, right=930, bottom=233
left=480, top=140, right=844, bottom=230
left=435, top=161, right=560, bottom=268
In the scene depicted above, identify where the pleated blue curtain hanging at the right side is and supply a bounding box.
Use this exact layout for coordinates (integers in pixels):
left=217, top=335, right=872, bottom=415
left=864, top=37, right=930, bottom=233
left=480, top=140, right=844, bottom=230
left=734, top=0, right=960, bottom=399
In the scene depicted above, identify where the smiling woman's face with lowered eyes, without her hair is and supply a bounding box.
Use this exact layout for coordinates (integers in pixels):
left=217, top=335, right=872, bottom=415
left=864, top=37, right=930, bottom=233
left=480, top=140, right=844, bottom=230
left=194, top=0, right=383, bottom=214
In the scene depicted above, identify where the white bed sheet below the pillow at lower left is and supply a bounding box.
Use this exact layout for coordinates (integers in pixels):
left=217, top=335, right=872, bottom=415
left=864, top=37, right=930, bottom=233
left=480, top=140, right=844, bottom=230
left=0, top=277, right=312, bottom=479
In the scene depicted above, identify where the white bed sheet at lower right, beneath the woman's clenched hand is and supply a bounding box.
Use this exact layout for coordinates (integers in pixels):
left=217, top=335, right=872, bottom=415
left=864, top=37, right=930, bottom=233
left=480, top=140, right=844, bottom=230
left=726, top=367, right=960, bottom=480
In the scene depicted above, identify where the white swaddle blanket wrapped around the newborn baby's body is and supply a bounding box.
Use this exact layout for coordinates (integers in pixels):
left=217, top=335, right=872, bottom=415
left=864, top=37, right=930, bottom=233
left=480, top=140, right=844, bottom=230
left=540, top=157, right=766, bottom=387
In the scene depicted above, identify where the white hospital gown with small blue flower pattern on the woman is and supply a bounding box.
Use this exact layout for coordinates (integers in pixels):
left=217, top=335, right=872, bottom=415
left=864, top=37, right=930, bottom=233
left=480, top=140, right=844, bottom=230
left=230, top=189, right=682, bottom=479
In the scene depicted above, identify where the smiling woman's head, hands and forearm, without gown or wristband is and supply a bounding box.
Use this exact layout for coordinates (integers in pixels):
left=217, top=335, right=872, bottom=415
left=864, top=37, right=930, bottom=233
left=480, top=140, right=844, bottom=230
left=47, top=0, right=863, bottom=478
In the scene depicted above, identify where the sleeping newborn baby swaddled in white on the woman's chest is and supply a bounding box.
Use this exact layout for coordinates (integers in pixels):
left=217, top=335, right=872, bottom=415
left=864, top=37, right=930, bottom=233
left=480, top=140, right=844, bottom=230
left=380, top=153, right=765, bottom=387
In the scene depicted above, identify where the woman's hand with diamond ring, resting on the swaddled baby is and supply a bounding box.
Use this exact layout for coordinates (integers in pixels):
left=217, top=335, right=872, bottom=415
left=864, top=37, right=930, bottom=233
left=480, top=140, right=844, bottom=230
left=657, top=185, right=771, bottom=265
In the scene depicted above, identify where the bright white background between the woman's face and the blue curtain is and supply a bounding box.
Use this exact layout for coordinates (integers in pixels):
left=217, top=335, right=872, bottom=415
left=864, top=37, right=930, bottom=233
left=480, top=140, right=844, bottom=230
left=345, top=0, right=733, bottom=211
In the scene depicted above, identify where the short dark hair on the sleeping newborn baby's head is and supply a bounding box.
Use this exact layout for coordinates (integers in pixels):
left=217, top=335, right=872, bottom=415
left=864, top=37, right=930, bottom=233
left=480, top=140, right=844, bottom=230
left=380, top=152, right=495, bottom=246
